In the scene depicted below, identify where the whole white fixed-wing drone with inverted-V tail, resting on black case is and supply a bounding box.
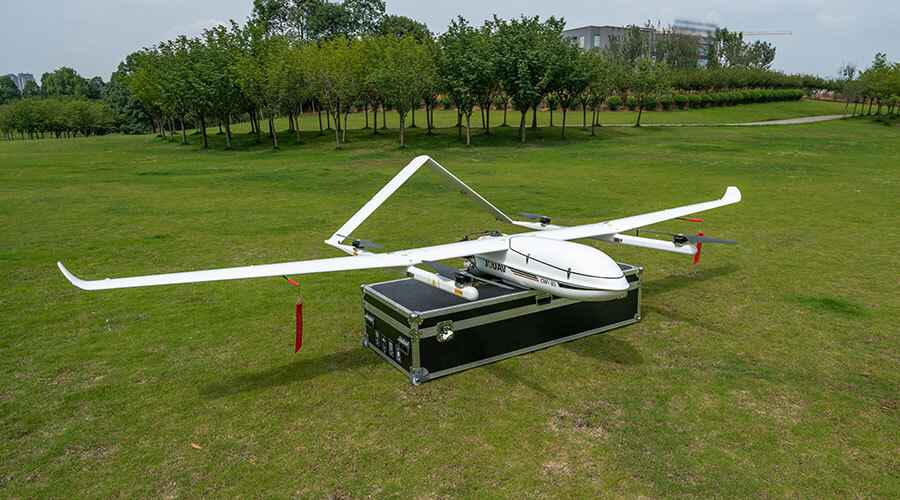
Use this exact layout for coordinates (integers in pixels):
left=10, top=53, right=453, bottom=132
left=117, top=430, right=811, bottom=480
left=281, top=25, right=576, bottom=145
left=57, top=156, right=741, bottom=301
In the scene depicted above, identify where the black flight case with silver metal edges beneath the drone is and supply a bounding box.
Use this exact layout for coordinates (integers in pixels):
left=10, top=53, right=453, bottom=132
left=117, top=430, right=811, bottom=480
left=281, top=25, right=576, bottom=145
left=362, top=263, right=643, bottom=385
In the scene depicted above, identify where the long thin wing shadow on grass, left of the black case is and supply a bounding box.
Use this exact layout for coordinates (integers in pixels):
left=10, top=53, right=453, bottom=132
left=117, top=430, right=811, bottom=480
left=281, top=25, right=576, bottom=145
left=201, top=349, right=382, bottom=399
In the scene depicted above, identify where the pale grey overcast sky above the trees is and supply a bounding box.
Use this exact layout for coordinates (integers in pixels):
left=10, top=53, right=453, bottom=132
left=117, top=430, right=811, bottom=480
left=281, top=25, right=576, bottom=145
left=0, top=0, right=900, bottom=80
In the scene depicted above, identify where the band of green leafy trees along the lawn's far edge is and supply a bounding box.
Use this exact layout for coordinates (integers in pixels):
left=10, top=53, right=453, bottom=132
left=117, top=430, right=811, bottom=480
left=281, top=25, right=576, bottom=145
left=0, top=0, right=881, bottom=149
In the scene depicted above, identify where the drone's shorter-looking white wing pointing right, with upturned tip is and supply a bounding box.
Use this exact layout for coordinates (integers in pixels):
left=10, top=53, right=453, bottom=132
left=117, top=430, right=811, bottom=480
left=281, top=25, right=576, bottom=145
left=541, top=186, right=741, bottom=240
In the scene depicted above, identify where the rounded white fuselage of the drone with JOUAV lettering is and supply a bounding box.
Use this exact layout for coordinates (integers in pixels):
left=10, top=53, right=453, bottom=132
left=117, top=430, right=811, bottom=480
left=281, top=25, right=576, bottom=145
left=468, top=235, right=629, bottom=301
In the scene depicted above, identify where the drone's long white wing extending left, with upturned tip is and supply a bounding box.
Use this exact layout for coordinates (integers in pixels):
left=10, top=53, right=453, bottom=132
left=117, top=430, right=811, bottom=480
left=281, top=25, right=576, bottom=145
left=57, top=237, right=509, bottom=290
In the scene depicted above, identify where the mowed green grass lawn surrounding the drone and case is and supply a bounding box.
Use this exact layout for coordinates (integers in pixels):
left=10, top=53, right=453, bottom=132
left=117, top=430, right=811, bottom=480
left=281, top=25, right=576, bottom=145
left=0, top=110, right=900, bottom=498
